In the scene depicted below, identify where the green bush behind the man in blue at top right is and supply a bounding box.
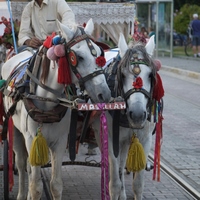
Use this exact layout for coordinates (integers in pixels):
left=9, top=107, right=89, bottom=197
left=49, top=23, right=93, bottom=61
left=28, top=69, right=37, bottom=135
left=174, top=4, right=200, bottom=34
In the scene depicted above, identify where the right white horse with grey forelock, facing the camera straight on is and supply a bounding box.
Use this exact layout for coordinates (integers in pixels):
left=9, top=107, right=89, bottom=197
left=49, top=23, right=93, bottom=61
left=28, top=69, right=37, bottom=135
left=92, top=34, right=159, bottom=200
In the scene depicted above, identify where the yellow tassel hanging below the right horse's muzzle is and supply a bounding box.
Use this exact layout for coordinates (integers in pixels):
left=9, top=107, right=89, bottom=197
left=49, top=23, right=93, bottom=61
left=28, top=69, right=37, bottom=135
left=126, top=135, right=146, bottom=172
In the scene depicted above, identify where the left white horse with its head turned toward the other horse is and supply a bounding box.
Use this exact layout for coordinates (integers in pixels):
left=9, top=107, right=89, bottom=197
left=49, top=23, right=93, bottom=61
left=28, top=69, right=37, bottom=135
left=2, top=19, right=111, bottom=200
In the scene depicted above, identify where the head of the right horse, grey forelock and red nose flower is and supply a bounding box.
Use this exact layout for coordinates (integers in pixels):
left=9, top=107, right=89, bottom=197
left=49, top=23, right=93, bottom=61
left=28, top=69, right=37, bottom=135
left=117, top=34, right=156, bottom=128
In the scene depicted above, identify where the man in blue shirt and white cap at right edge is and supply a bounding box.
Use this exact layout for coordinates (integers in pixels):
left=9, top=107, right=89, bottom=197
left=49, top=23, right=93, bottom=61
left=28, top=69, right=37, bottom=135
left=191, top=13, right=200, bottom=57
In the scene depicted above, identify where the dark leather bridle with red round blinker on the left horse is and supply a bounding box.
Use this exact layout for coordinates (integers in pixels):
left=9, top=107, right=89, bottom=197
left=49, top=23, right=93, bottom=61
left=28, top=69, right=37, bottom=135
left=65, top=27, right=104, bottom=91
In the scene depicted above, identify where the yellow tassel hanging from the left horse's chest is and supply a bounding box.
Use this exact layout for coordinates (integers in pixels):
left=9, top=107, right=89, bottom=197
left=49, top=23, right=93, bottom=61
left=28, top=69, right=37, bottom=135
left=29, top=128, right=49, bottom=166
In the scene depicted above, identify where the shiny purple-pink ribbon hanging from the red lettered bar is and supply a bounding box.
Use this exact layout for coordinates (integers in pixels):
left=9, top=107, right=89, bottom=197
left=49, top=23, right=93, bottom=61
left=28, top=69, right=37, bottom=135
left=97, top=103, right=110, bottom=200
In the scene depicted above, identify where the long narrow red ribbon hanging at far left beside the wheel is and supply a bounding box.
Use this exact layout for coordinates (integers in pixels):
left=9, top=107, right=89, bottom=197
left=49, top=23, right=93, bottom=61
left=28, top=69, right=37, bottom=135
left=8, top=117, right=14, bottom=191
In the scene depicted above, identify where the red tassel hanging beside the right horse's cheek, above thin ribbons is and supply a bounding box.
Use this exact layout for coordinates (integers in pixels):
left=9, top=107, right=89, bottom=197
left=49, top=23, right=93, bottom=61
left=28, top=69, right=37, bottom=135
left=153, top=73, right=164, bottom=102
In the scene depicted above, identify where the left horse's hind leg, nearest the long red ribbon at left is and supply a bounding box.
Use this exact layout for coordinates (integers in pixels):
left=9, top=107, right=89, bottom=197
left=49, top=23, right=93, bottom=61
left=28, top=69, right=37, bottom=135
left=13, top=127, right=28, bottom=200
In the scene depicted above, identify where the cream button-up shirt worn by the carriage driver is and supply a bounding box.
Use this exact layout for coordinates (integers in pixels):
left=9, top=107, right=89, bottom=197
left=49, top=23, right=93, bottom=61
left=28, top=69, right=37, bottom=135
left=18, top=0, right=75, bottom=46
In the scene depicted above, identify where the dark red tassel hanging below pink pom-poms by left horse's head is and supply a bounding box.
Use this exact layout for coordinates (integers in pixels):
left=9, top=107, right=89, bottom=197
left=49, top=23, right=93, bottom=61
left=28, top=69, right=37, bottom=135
left=58, top=56, right=72, bottom=85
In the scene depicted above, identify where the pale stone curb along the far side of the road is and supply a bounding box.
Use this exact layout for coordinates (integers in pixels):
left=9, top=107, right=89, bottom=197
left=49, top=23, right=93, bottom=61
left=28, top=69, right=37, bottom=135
left=161, top=65, right=200, bottom=80
